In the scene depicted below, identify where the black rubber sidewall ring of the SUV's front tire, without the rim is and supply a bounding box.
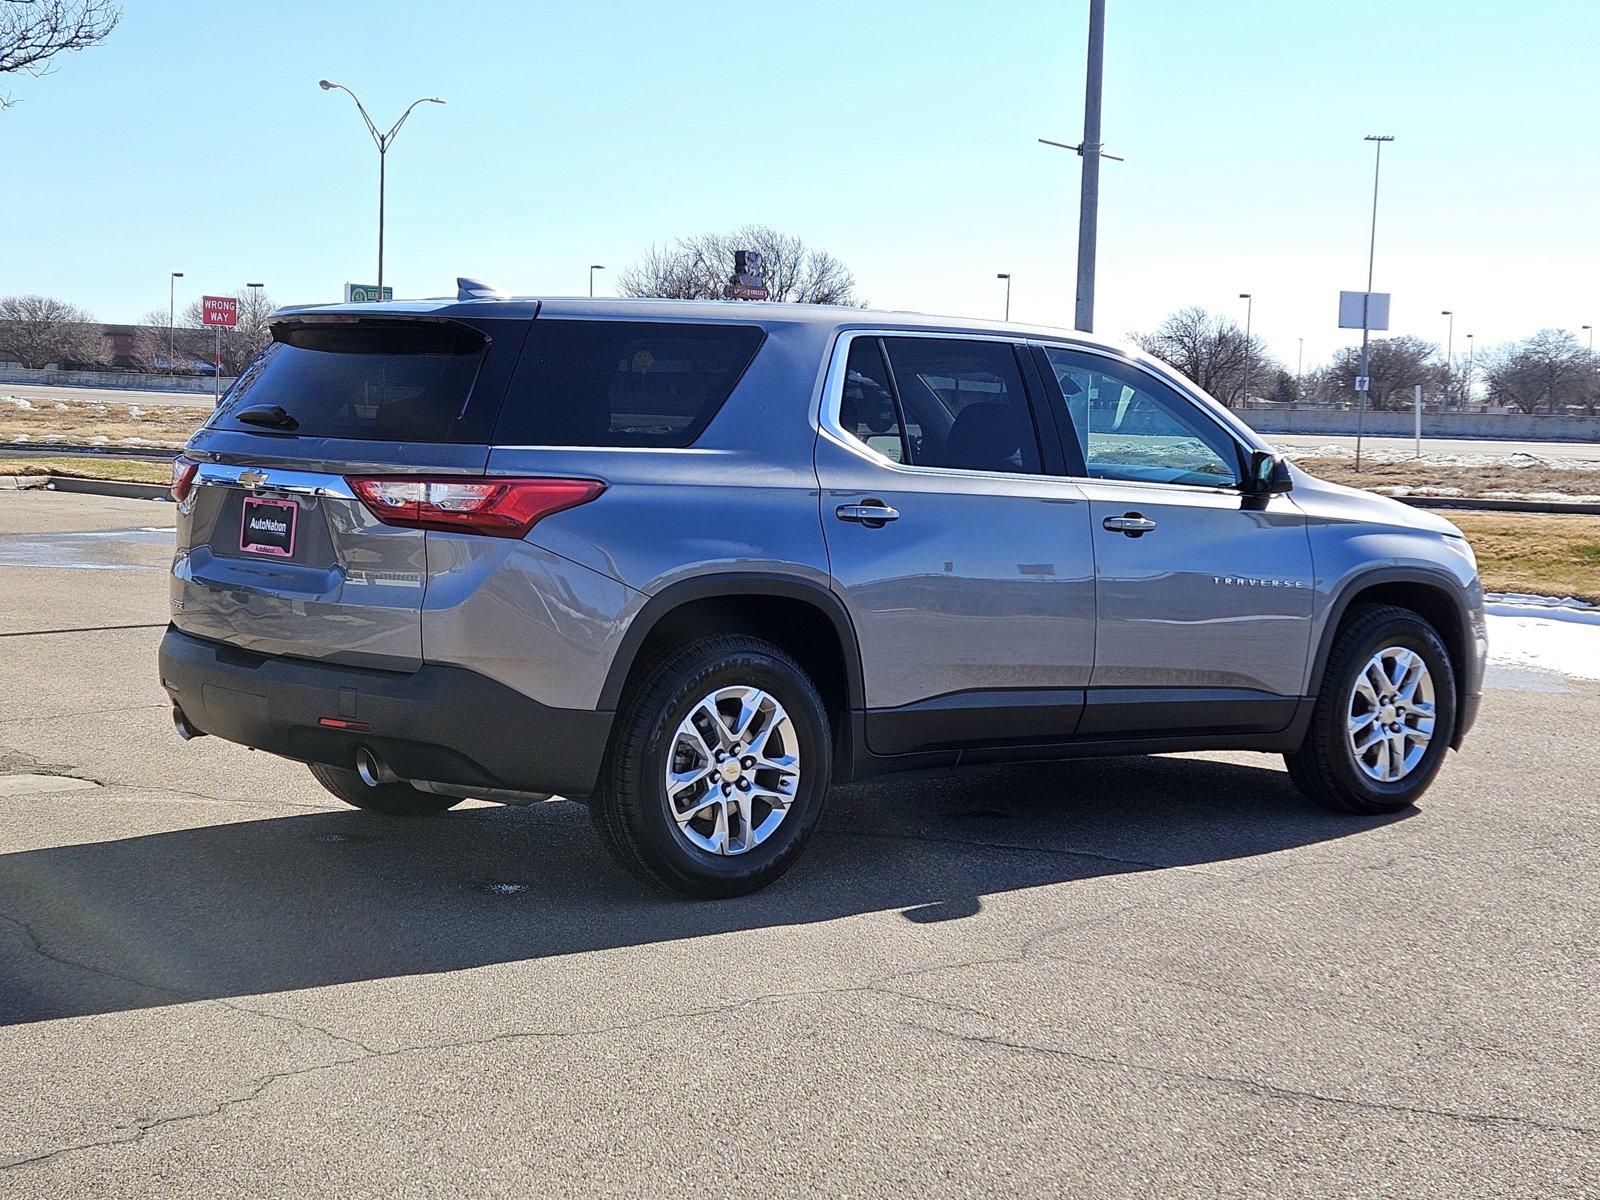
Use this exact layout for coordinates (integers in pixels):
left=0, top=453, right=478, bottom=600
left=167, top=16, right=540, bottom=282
left=1322, top=616, right=1456, bottom=808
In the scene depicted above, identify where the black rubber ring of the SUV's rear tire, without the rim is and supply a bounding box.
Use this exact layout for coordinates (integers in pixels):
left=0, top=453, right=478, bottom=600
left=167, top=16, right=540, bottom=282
left=624, top=650, right=832, bottom=894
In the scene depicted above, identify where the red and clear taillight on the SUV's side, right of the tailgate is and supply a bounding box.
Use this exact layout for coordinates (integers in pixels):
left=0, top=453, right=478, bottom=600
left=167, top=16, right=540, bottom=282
left=349, top=475, right=605, bottom=538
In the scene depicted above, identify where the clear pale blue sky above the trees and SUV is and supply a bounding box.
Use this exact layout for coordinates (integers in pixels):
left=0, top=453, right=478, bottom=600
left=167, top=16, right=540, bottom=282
left=0, top=0, right=1600, bottom=370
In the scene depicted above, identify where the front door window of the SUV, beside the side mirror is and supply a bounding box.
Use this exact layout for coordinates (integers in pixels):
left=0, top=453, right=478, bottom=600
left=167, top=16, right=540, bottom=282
left=1045, top=347, right=1238, bottom=488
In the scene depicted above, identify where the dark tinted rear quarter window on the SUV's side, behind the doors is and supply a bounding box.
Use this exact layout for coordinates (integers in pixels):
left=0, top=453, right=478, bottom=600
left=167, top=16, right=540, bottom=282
left=494, top=317, right=766, bottom=446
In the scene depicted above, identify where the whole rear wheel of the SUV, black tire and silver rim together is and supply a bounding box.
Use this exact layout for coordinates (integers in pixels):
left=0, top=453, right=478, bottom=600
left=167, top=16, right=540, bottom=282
left=589, top=635, right=834, bottom=899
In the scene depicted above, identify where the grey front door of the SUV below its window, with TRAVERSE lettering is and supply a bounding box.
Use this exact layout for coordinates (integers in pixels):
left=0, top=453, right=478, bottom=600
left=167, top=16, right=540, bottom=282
left=1082, top=480, right=1315, bottom=699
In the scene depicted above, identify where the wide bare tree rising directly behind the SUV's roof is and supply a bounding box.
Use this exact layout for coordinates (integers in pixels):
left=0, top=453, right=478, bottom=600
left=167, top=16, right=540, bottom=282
left=618, top=226, right=859, bottom=304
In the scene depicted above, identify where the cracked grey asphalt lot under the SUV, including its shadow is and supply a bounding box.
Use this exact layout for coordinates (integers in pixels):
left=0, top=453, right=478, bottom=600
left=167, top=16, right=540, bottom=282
left=0, top=491, right=1600, bottom=1198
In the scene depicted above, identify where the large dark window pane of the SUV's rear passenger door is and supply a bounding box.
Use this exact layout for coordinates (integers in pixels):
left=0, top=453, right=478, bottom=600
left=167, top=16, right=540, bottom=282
left=883, top=338, right=1043, bottom=475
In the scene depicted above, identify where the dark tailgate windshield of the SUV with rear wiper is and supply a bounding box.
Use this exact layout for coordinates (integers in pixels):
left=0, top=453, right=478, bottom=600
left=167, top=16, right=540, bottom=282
left=211, top=320, right=488, bottom=442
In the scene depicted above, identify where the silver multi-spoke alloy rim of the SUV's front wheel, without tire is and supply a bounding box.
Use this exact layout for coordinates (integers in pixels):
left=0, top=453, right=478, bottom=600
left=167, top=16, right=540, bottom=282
left=1346, top=646, right=1434, bottom=784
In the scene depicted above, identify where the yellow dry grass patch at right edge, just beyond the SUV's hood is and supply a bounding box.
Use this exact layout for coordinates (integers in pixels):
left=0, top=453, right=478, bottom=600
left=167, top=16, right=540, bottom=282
left=1443, top=512, right=1600, bottom=603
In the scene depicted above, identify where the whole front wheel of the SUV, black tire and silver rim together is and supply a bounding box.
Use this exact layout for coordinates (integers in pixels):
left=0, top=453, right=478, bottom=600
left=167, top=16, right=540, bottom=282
left=1283, top=605, right=1456, bottom=813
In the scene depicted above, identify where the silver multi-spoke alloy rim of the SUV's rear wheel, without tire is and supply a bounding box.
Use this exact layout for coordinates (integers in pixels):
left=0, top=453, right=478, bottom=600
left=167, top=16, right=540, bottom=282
left=662, top=686, right=800, bottom=854
